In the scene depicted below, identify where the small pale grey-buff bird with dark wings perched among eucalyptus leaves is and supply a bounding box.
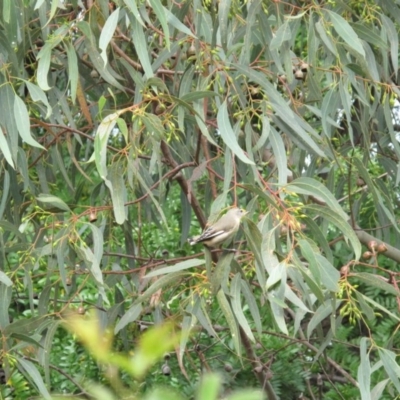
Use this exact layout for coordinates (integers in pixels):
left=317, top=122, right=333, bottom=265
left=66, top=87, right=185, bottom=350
left=188, top=208, right=247, bottom=247
